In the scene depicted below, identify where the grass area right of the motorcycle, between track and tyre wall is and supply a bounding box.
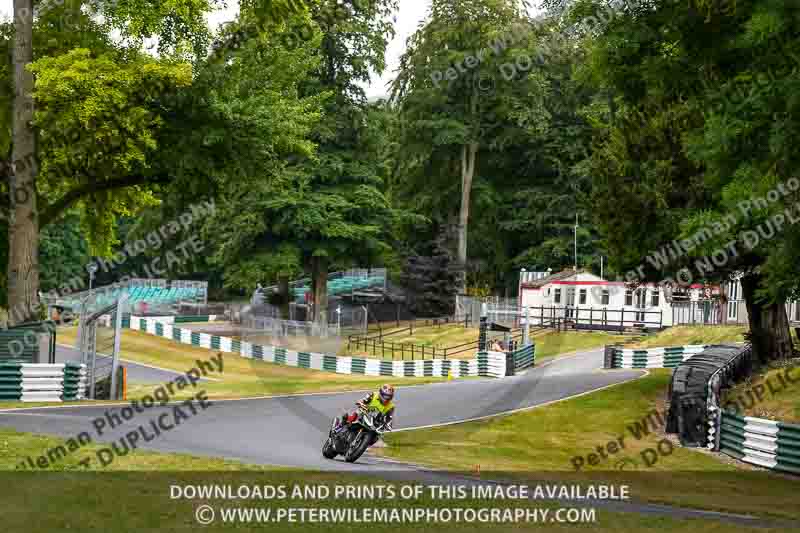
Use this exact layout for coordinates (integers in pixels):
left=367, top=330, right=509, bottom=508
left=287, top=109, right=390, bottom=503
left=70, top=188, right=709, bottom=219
left=378, top=371, right=800, bottom=517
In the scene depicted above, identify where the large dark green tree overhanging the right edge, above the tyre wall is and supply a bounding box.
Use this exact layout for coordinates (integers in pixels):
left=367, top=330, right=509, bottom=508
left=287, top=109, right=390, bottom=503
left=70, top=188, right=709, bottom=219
left=580, top=1, right=800, bottom=361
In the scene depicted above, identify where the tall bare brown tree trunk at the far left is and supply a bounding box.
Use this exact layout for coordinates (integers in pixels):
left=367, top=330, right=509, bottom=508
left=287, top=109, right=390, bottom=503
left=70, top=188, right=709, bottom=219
left=8, top=0, right=39, bottom=325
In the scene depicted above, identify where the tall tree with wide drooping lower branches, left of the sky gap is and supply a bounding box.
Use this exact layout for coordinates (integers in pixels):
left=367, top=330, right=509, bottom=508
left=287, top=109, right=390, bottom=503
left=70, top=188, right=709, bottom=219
left=208, top=0, right=404, bottom=322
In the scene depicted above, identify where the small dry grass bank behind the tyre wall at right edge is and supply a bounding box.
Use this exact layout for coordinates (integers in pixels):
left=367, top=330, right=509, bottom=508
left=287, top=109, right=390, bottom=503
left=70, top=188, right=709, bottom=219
left=723, top=361, right=800, bottom=424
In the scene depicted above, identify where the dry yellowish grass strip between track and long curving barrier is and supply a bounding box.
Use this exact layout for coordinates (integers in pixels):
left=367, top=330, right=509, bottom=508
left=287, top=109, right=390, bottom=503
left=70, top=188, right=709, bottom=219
left=50, top=328, right=444, bottom=399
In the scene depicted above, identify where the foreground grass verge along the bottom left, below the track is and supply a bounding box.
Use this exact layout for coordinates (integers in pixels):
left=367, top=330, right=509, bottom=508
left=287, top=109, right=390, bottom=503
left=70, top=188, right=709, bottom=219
left=0, top=429, right=779, bottom=533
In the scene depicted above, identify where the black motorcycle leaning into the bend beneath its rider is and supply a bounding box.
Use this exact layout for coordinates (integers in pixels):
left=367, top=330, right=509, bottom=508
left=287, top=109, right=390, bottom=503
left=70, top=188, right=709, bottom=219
left=322, top=406, right=389, bottom=463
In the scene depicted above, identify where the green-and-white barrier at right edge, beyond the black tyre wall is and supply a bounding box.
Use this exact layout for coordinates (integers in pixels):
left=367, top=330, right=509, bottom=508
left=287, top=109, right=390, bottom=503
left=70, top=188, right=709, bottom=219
left=719, top=411, right=800, bottom=474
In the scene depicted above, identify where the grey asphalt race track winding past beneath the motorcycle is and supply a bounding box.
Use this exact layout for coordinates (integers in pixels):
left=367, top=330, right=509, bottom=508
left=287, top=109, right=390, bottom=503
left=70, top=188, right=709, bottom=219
left=0, top=350, right=643, bottom=470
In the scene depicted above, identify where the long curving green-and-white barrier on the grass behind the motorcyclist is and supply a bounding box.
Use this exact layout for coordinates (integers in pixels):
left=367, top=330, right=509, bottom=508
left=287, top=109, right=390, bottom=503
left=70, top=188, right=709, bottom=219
left=130, top=316, right=506, bottom=377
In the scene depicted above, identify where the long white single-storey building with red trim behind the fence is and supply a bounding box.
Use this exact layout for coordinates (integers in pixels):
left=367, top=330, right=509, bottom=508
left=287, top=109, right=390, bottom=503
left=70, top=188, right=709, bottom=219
left=518, top=270, right=747, bottom=329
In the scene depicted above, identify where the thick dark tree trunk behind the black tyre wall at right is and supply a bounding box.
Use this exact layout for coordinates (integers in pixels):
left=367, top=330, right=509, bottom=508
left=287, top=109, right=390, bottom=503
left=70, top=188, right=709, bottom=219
left=742, top=274, right=792, bottom=363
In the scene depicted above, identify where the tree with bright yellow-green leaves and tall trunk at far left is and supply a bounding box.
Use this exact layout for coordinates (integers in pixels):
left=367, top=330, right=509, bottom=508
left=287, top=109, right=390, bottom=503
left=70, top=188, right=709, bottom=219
left=0, top=0, right=314, bottom=321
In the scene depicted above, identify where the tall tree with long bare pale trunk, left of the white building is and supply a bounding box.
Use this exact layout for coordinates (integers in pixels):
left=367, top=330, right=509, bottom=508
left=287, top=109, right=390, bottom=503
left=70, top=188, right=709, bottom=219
left=393, top=0, right=540, bottom=292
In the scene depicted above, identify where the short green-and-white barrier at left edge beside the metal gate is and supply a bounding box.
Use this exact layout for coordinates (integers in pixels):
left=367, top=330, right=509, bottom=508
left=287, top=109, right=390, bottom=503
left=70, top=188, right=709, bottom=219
left=0, top=361, right=86, bottom=402
